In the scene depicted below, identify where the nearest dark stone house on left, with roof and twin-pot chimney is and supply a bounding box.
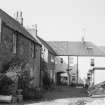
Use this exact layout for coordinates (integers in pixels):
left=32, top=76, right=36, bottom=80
left=0, top=9, right=41, bottom=87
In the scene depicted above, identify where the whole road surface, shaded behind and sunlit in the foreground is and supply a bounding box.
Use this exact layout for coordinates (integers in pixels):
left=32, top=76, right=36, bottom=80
left=0, top=87, right=105, bottom=105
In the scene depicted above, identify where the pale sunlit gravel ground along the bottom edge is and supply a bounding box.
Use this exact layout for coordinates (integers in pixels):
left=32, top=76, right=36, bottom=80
left=24, top=97, right=105, bottom=105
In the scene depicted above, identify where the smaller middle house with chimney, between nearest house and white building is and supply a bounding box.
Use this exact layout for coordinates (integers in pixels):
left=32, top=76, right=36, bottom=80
left=27, top=28, right=56, bottom=84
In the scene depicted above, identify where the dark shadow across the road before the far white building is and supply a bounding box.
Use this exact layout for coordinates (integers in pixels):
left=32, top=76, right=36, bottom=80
left=42, top=87, right=88, bottom=101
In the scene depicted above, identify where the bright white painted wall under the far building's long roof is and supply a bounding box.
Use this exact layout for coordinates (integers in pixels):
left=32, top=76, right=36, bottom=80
left=57, top=57, right=105, bottom=83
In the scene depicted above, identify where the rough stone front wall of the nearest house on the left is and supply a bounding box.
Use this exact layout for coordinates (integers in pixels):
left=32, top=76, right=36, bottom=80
left=0, top=20, right=40, bottom=87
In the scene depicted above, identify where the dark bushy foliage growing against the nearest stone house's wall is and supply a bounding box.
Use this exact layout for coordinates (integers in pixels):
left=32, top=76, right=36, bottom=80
left=0, top=56, right=42, bottom=99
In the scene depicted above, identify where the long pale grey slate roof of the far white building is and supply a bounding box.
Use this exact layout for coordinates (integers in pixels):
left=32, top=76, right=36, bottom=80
left=47, top=41, right=105, bottom=56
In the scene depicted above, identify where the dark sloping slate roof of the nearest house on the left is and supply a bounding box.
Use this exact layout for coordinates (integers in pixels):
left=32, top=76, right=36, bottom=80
left=0, top=9, right=39, bottom=44
